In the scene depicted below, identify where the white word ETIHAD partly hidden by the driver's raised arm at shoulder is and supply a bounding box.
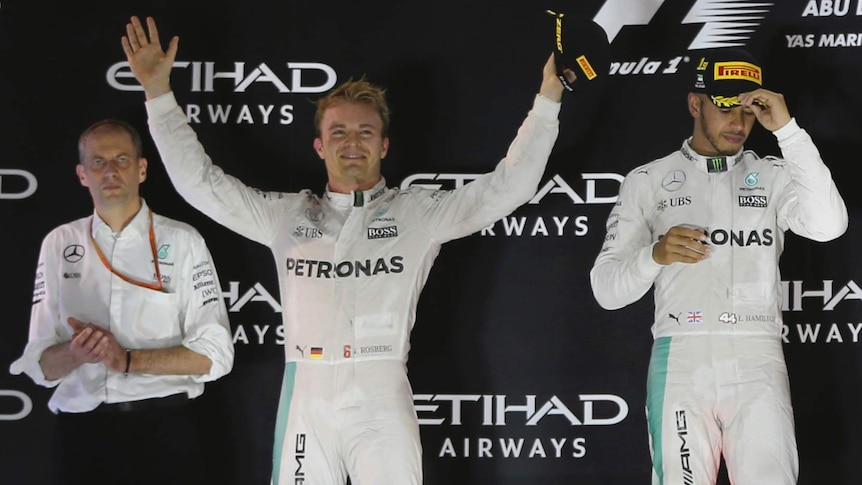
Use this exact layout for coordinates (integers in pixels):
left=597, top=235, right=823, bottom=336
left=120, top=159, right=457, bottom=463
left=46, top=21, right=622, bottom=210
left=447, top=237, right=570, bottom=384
left=401, top=173, right=625, bottom=204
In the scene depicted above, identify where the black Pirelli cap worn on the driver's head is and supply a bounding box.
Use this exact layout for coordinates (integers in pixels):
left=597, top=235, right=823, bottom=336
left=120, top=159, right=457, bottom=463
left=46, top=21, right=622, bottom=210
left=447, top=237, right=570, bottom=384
left=693, top=48, right=763, bottom=108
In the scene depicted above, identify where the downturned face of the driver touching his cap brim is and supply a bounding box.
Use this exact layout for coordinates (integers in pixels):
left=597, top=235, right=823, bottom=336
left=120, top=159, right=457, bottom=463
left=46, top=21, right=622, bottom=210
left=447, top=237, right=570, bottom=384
left=688, top=93, right=756, bottom=157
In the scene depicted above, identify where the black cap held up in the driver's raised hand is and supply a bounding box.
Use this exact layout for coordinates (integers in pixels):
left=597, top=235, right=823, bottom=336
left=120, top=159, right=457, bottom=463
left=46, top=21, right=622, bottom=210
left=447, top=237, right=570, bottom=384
left=547, top=10, right=611, bottom=91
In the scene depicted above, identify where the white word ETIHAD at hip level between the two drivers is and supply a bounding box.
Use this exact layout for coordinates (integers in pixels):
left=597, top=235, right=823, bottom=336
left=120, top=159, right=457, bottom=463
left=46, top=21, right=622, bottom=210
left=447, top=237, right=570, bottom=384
left=413, top=394, right=629, bottom=426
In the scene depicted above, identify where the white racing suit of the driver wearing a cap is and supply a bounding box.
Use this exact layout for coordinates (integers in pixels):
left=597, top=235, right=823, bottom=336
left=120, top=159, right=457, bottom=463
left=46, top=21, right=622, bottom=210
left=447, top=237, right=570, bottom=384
left=590, top=120, right=847, bottom=485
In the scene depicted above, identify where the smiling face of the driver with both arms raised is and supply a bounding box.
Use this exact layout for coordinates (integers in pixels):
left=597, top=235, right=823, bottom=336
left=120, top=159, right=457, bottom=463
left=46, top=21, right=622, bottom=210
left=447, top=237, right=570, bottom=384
left=314, top=102, right=389, bottom=193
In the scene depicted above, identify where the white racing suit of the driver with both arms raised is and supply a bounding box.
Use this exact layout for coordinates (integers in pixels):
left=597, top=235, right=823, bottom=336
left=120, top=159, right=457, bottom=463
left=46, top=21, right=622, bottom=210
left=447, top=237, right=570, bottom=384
left=147, top=94, right=560, bottom=485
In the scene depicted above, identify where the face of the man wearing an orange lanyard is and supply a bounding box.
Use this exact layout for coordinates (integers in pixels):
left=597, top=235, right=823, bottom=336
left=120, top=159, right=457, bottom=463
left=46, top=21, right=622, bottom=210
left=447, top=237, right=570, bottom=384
left=76, top=125, right=147, bottom=210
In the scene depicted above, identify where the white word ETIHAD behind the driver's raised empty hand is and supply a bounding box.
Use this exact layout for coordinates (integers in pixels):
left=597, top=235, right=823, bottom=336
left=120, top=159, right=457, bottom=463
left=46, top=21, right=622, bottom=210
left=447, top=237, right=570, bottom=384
left=106, top=61, right=337, bottom=93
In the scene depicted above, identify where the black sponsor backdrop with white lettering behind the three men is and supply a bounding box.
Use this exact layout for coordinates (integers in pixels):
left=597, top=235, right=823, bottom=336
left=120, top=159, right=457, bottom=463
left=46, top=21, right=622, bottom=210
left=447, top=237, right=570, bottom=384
left=0, top=0, right=862, bottom=485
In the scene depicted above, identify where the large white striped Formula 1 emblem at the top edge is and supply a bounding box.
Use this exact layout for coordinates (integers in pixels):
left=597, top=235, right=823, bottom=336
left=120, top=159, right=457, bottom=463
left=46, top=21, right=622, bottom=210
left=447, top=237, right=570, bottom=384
left=593, top=0, right=773, bottom=50
